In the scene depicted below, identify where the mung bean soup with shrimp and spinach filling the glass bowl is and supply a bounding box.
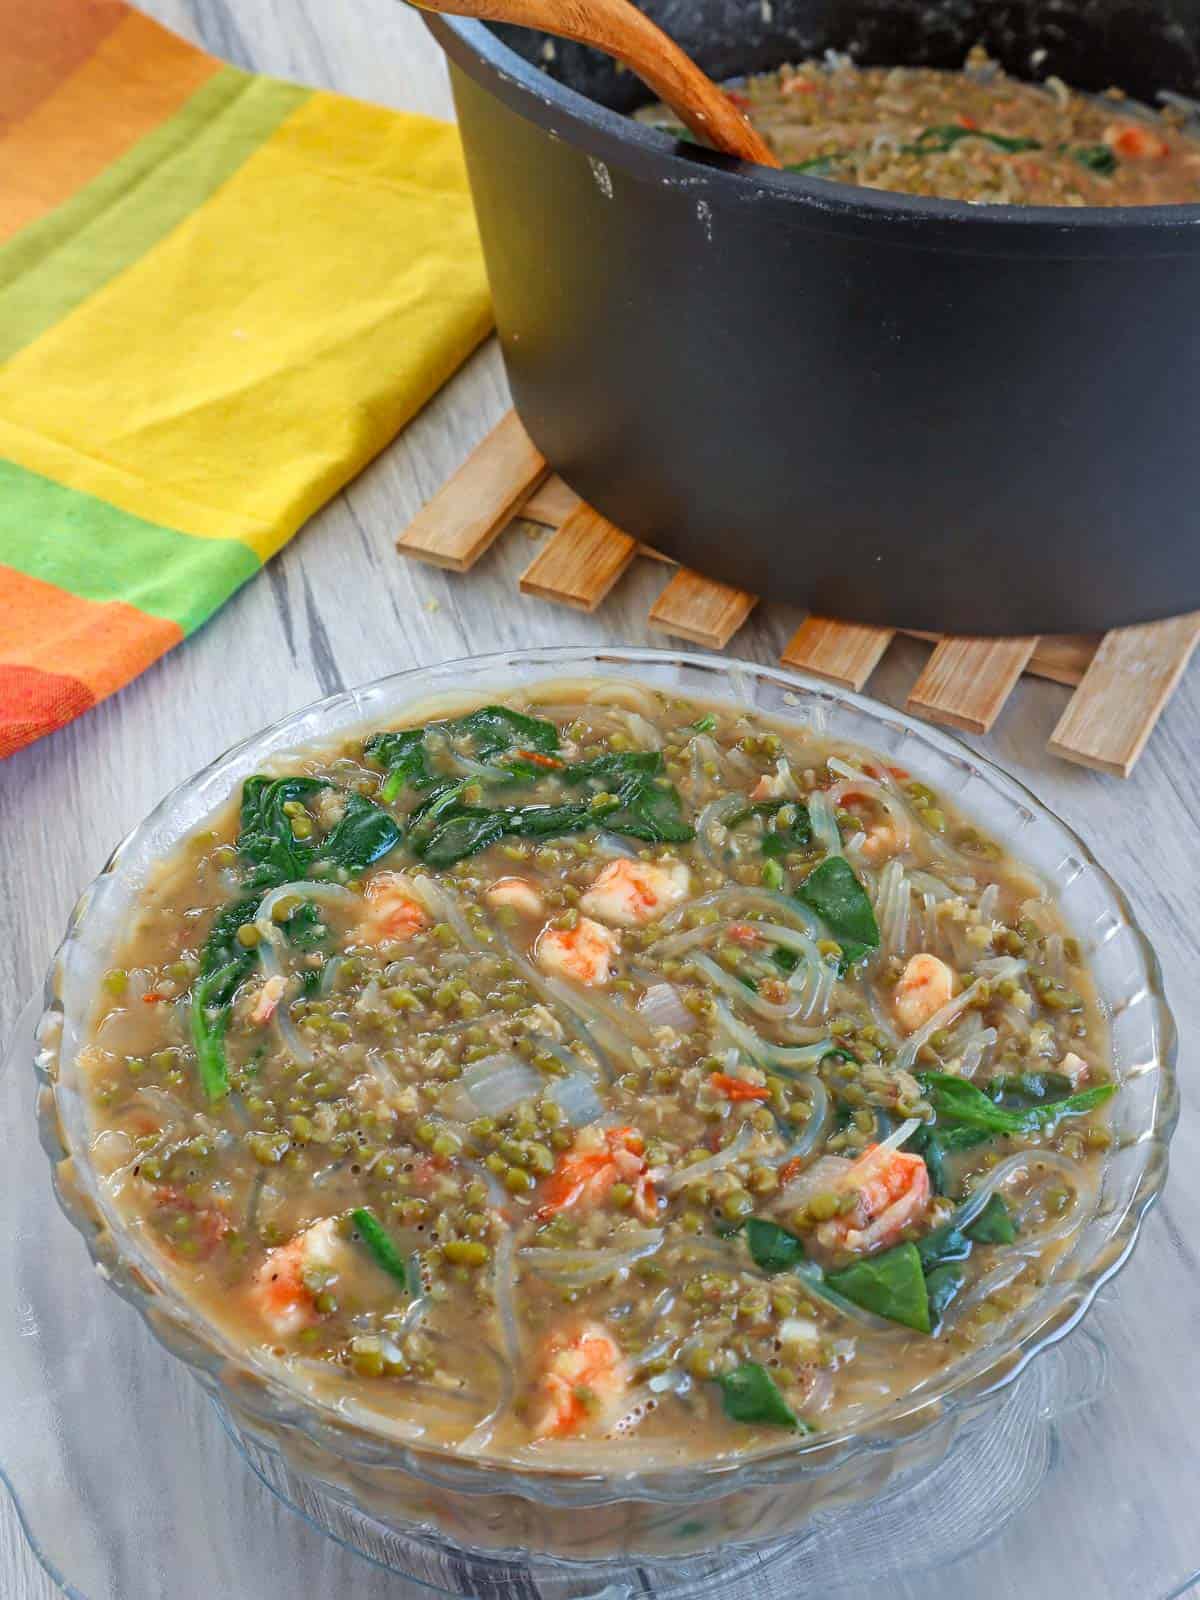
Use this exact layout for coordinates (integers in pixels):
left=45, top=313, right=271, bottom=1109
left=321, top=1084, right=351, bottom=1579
left=85, top=683, right=1114, bottom=1462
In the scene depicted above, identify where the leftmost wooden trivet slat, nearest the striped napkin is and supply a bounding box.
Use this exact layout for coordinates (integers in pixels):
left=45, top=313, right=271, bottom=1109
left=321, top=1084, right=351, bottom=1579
left=397, top=411, right=550, bottom=573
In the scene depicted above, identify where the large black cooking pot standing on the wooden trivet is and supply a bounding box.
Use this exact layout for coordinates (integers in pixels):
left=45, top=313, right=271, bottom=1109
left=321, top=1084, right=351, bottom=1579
left=427, top=0, right=1200, bottom=634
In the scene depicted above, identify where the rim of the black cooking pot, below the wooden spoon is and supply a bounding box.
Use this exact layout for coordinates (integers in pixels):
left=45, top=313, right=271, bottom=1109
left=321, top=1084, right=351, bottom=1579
left=421, top=11, right=1200, bottom=256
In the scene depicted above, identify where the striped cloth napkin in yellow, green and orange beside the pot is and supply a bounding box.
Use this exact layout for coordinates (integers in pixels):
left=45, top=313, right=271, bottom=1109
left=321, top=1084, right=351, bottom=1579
left=0, top=0, right=491, bottom=755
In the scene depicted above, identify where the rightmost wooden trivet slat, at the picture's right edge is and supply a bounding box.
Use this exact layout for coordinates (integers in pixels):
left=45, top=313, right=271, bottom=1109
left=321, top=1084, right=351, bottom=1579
left=1050, top=611, right=1200, bottom=778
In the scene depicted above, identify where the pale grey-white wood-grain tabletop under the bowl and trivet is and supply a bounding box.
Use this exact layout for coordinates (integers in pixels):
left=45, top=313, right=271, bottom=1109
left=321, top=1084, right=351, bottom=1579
left=0, top=0, right=1200, bottom=1600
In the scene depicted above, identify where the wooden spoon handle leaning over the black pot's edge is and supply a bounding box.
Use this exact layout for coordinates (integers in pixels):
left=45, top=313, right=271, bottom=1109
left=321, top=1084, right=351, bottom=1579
left=413, top=0, right=781, bottom=166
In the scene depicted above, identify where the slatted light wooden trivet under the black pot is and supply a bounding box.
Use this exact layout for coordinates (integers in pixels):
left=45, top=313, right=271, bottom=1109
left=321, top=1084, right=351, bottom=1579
left=397, top=411, right=1200, bottom=776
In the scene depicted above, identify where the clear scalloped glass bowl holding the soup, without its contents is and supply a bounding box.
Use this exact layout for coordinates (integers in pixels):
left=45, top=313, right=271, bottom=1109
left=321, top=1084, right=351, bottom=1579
left=37, top=646, right=1178, bottom=1563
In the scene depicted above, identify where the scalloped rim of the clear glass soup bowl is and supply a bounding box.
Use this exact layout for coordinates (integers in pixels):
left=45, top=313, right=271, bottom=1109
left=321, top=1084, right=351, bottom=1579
left=37, top=645, right=1178, bottom=1504
